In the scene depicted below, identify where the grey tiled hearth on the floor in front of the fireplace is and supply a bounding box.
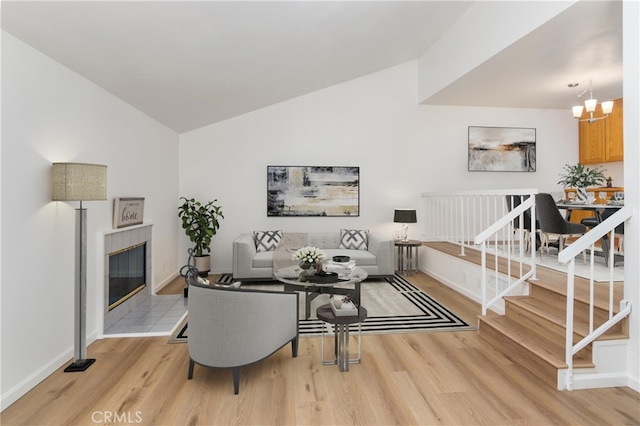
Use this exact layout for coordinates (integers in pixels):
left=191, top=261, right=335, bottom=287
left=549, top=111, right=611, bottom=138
left=104, top=294, right=187, bottom=336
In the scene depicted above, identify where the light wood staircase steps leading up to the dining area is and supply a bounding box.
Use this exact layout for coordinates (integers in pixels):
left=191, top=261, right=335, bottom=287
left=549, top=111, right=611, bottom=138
left=426, top=242, right=629, bottom=389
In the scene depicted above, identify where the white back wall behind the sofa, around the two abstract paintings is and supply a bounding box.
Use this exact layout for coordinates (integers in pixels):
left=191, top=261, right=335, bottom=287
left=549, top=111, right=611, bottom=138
left=179, top=62, right=578, bottom=272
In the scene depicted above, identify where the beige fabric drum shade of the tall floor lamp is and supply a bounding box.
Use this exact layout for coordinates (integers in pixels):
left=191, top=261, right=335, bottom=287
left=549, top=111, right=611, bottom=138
left=52, top=163, right=107, bottom=201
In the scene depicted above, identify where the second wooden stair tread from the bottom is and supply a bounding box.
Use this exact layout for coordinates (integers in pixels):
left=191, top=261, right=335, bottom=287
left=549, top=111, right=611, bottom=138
left=504, top=296, right=629, bottom=340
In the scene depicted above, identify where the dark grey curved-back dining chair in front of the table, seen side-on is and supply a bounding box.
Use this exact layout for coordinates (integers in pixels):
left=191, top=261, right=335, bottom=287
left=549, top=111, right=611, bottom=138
left=536, top=193, right=587, bottom=255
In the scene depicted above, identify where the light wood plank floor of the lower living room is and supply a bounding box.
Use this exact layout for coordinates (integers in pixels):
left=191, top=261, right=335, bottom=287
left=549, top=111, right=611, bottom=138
left=0, top=274, right=640, bottom=425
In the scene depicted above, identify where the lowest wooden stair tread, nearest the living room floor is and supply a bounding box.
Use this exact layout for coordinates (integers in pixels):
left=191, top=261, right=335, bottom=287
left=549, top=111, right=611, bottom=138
left=479, top=316, right=594, bottom=369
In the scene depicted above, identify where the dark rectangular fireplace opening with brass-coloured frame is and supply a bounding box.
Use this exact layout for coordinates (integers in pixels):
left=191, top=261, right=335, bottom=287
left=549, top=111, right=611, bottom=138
left=109, top=243, right=147, bottom=310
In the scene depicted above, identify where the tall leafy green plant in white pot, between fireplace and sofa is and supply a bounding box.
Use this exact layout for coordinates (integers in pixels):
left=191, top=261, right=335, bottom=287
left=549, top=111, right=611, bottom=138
left=178, top=197, right=224, bottom=277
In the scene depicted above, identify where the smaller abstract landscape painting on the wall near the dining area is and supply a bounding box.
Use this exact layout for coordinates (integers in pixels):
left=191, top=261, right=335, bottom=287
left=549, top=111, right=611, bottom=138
left=469, top=126, right=536, bottom=172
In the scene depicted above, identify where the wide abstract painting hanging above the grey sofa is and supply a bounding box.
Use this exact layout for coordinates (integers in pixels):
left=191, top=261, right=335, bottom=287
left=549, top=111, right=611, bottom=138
left=267, top=166, right=360, bottom=216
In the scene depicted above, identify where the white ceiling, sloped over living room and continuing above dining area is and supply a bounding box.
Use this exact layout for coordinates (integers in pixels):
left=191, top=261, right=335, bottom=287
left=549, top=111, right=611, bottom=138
left=2, top=1, right=622, bottom=132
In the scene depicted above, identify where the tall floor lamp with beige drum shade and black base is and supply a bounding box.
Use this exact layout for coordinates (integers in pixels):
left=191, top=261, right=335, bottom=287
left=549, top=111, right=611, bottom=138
left=52, top=163, right=107, bottom=372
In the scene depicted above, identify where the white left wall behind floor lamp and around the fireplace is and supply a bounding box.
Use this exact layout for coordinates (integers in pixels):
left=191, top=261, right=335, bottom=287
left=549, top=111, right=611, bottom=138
left=1, top=32, right=178, bottom=408
